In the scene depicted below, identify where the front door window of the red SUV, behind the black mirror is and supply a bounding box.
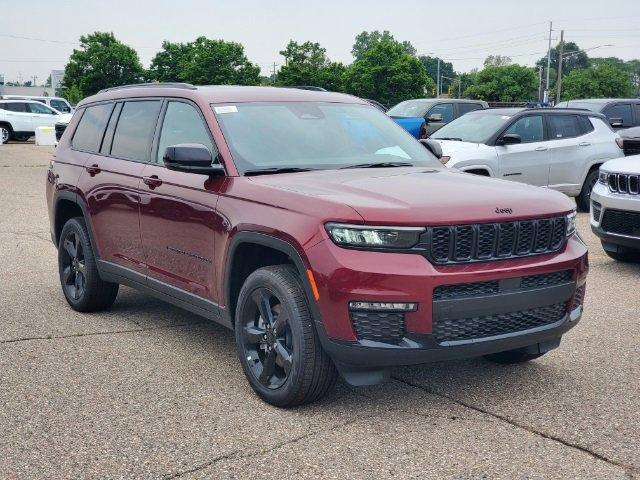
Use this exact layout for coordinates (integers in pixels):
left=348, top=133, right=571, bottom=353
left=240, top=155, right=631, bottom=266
left=157, top=102, right=217, bottom=163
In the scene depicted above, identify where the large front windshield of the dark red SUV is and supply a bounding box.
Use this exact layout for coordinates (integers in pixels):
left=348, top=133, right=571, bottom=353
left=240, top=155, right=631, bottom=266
left=213, top=102, right=441, bottom=173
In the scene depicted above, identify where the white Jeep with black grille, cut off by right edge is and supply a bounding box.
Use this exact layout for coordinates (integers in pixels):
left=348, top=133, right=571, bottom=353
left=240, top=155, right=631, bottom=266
left=591, top=155, right=640, bottom=261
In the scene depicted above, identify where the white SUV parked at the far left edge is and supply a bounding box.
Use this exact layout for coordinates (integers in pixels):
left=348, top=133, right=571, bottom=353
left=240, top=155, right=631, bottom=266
left=0, top=100, right=72, bottom=143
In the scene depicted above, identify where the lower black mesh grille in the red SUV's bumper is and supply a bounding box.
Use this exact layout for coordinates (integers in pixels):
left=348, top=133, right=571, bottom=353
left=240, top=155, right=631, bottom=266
left=433, top=302, right=567, bottom=344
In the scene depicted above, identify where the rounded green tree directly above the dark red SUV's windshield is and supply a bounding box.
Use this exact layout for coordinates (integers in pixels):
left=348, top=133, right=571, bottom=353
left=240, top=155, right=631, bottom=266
left=345, top=40, right=435, bottom=105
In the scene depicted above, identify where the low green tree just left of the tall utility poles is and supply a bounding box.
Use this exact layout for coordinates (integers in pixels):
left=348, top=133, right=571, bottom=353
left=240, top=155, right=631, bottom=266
left=464, top=64, right=538, bottom=102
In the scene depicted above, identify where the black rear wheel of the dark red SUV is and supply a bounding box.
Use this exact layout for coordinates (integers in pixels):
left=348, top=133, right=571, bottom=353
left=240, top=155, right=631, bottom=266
left=58, top=217, right=119, bottom=312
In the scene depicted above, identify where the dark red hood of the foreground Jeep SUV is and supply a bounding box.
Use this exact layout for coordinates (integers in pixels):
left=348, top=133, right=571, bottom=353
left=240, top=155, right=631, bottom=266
left=252, top=167, right=574, bottom=226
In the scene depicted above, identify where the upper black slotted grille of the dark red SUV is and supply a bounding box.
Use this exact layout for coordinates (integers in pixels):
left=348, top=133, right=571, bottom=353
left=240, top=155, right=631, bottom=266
left=427, top=217, right=567, bottom=264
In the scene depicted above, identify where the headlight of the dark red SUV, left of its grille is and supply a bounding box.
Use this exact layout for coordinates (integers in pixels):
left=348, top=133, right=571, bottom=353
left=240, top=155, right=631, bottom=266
left=326, top=223, right=425, bottom=250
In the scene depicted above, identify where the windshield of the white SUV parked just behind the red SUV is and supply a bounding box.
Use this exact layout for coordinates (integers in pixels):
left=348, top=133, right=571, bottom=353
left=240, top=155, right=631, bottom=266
left=431, top=111, right=511, bottom=143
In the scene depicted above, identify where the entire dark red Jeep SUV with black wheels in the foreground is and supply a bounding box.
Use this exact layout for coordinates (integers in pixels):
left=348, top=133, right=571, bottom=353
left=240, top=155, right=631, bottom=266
left=47, top=84, right=587, bottom=406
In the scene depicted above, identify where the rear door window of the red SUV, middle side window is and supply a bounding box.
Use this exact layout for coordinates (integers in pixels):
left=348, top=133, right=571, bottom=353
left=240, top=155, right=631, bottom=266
left=111, top=100, right=161, bottom=161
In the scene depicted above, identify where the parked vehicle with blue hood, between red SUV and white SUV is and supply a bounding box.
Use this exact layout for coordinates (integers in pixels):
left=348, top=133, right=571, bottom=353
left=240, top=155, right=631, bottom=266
left=387, top=98, right=489, bottom=138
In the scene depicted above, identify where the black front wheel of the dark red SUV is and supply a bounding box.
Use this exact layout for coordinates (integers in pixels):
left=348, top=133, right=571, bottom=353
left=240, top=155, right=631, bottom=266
left=235, top=265, right=338, bottom=407
